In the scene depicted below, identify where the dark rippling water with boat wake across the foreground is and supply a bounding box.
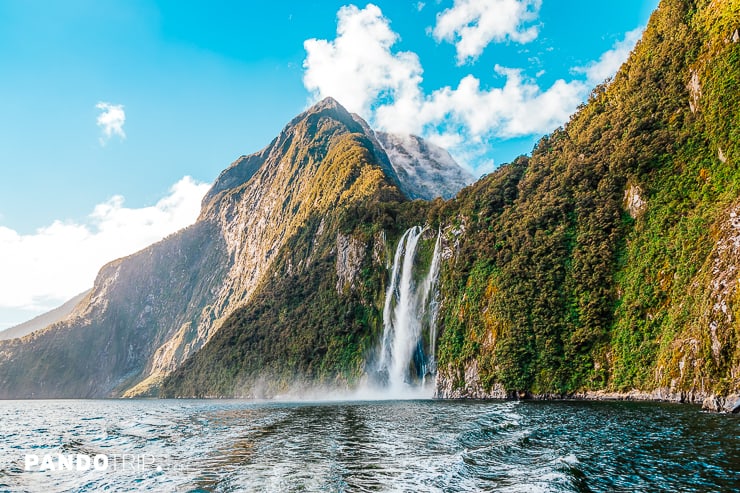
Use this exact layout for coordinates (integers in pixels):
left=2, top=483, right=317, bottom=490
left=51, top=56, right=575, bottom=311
left=0, top=400, right=740, bottom=493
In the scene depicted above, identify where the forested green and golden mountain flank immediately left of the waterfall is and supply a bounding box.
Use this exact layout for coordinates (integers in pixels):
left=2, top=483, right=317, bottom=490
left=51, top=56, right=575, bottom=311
left=161, top=121, right=430, bottom=397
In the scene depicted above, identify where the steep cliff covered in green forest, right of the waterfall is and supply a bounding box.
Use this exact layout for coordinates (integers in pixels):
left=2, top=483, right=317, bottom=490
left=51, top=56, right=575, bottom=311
left=430, top=0, right=740, bottom=402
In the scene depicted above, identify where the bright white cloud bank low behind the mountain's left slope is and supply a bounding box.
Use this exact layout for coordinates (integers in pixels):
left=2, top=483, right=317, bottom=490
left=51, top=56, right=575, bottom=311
left=0, top=176, right=209, bottom=310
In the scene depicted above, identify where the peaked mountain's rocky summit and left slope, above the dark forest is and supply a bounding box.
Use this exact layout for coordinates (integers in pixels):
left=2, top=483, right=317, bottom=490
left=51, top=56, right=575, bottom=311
left=0, top=99, right=454, bottom=397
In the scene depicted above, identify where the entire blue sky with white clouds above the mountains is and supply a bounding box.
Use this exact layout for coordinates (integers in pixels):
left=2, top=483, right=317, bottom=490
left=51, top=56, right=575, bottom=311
left=0, top=0, right=657, bottom=329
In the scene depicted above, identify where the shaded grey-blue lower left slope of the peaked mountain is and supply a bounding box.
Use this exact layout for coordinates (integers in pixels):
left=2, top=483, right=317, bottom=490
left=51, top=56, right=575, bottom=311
left=0, top=223, right=227, bottom=398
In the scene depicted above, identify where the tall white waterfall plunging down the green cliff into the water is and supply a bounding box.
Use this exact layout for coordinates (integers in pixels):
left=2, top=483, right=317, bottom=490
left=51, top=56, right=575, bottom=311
left=377, top=226, right=441, bottom=392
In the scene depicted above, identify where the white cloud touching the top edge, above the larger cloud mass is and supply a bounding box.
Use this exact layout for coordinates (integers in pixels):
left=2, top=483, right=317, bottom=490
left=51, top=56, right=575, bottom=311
left=432, top=0, right=542, bottom=65
